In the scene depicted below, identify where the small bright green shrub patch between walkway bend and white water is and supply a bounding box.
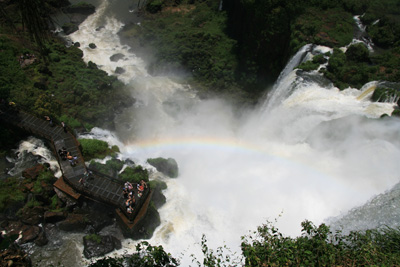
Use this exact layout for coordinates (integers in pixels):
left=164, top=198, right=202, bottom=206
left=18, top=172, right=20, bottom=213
left=78, top=138, right=119, bottom=161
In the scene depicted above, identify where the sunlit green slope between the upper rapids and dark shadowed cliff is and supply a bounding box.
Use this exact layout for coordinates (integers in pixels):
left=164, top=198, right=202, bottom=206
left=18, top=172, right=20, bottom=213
left=122, top=1, right=244, bottom=98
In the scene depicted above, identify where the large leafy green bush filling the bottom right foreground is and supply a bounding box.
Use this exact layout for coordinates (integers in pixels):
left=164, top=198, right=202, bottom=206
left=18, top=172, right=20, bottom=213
left=242, top=221, right=400, bottom=266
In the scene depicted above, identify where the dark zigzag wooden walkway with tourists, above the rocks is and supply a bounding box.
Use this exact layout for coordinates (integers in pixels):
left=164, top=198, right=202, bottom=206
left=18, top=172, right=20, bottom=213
left=0, top=109, right=150, bottom=222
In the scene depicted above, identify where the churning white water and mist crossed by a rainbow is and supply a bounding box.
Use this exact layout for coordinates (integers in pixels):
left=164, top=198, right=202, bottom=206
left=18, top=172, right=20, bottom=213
left=64, top=1, right=400, bottom=266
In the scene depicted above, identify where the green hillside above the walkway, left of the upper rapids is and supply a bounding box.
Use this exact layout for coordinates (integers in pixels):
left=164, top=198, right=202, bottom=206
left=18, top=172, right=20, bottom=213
left=0, top=0, right=133, bottom=131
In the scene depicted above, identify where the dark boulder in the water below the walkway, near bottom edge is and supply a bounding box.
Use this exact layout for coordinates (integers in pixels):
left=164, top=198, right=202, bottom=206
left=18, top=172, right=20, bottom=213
left=83, top=235, right=122, bottom=259
